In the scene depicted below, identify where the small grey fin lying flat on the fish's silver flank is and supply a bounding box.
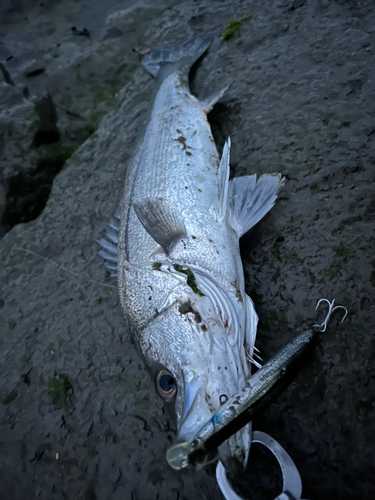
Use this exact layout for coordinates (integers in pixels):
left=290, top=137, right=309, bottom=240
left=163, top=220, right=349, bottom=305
left=133, top=198, right=186, bottom=254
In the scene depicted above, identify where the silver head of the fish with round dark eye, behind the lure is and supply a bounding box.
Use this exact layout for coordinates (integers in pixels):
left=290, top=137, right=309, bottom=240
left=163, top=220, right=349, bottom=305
left=141, top=293, right=251, bottom=471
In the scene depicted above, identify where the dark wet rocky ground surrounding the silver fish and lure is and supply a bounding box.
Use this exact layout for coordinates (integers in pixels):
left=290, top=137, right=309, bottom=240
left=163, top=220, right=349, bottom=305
left=0, top=0, right=375, bottom=500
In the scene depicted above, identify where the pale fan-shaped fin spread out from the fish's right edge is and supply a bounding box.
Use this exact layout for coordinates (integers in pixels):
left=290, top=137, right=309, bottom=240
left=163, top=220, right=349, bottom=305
left=228, top=174, right=284, bottom=238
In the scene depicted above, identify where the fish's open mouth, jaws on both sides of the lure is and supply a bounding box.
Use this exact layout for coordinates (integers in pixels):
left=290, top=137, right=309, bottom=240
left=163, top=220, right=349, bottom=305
left=178, top=377, right=252, bottom=473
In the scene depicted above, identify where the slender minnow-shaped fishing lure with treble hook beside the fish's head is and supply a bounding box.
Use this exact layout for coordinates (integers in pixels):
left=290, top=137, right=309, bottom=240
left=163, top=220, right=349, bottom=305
left=167, top=299, right=348, bottom=470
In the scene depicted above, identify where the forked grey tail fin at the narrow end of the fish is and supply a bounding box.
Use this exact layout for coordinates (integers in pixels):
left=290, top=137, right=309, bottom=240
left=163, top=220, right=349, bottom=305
left=142, top=36, right=214, bottom=77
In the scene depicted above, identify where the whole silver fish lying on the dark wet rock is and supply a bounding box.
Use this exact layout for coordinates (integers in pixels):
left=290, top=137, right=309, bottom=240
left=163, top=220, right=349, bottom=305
left=98, top=36, right=284, bottom=470
